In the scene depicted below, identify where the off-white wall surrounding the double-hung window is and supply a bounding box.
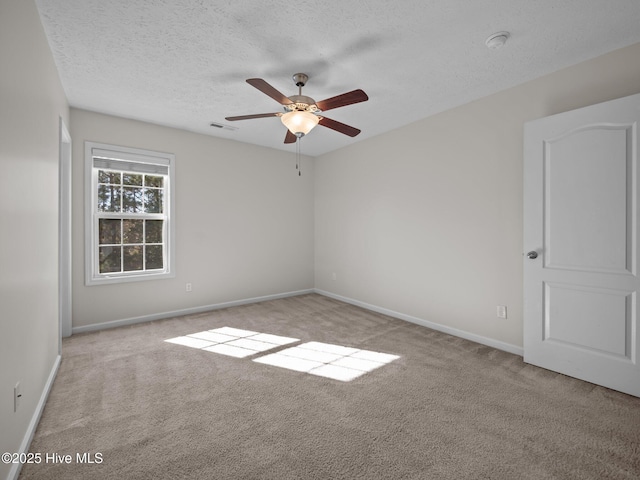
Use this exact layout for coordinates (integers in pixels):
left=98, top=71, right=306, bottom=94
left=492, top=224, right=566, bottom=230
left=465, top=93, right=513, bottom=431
left=70, top=109, right=314, bottom=331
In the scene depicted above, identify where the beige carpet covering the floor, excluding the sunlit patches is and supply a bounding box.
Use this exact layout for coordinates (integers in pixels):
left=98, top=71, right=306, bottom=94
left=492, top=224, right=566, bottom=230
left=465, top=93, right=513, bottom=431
left=21, top=295, right=640, bottom=480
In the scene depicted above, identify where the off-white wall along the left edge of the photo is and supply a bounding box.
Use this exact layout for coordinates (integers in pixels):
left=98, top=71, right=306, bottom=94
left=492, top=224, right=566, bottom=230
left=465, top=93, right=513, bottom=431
left=0, top=0, right=69, bottom=479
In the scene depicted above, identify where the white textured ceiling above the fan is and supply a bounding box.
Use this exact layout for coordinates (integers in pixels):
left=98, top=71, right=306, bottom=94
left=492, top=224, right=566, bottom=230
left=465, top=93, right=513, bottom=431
left=36, top=0, right=640, bottom=156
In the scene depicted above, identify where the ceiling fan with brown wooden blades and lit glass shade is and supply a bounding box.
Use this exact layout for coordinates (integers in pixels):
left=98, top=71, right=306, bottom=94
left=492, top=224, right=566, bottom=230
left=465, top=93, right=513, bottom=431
left=226, top=73, right=369, bottom=143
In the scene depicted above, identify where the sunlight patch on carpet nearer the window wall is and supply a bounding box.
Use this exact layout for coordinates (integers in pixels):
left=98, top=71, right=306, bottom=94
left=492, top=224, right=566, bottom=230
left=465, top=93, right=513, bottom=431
left=165, top=327, right=299, bottom=358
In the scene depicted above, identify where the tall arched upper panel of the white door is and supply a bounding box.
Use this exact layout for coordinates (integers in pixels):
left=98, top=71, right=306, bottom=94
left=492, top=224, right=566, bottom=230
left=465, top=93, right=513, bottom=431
left=544, top=125, right=633, bottom=273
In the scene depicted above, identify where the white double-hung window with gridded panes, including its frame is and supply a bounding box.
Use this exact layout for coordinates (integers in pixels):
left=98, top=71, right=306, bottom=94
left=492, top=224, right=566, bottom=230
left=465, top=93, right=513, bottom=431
left=85, top=142, right=174, bottom=285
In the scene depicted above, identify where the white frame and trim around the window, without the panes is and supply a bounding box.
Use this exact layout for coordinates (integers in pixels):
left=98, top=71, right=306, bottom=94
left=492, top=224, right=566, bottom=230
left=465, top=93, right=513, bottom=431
left=84, top=142, right=175, bottom=286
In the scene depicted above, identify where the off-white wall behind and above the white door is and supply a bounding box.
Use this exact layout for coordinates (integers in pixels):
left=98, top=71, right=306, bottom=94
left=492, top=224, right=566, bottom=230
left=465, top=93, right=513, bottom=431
left=315, top=44, right=640, bottom=351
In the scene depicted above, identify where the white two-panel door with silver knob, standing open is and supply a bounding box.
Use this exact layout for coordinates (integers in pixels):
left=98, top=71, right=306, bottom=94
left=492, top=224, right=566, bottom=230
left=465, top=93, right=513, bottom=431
left=524, top=94, right=640, bottom=396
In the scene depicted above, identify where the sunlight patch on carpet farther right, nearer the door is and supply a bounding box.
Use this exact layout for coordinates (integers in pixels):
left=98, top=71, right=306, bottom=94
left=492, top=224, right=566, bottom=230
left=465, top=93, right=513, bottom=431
left=253, top=342, right=400, bottom=382
